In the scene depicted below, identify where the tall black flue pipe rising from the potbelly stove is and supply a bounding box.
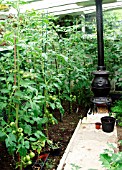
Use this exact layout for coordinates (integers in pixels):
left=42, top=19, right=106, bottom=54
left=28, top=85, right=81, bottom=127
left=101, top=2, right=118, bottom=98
left=96, top=0, right=106, bottom=70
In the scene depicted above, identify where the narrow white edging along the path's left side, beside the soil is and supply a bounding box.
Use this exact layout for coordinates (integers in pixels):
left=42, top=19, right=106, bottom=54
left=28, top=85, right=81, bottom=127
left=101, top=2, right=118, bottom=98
left=56, top=119, right=81, bottom=170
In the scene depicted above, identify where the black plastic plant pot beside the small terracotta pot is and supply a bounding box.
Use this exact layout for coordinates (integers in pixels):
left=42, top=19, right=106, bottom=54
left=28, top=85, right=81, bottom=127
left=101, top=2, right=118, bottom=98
left=101, top=116, right=116, bottom=133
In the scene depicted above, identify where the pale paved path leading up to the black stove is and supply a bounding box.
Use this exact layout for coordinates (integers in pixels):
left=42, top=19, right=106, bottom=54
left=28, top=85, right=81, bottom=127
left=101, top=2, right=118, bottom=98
left=57, top=114, right=118, bottom=170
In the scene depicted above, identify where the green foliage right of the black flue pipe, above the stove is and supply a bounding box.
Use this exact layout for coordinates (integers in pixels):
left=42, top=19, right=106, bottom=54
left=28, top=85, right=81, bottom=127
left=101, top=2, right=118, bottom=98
left=104, top=10, right=122, bottom=87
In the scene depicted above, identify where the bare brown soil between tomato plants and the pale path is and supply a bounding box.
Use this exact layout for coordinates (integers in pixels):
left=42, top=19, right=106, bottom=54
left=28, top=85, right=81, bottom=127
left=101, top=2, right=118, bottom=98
left=44, top=105, right=88, bottom=170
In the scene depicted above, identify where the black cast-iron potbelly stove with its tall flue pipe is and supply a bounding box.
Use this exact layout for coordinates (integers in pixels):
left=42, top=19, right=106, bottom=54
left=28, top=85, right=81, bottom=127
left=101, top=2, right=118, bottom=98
left=91, top=0, right=112, bottom=113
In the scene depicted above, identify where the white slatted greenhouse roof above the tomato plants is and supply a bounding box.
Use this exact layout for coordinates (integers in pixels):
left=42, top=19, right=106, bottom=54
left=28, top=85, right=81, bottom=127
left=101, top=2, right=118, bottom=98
left=0, top=0, right=122, bottom=16
